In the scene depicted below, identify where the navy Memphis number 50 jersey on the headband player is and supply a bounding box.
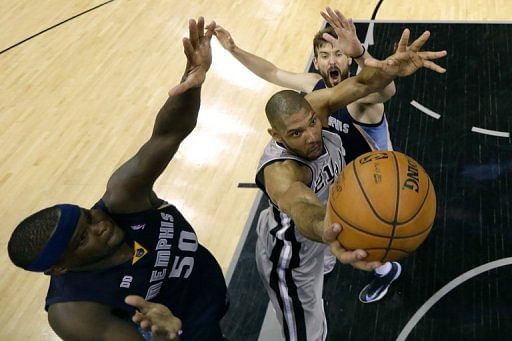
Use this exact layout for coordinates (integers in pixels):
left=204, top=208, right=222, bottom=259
left=46, top=201, right=227, bottom=340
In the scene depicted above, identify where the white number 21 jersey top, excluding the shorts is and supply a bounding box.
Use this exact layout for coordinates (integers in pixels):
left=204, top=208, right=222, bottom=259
left=256, top=129, right=345, bottom=249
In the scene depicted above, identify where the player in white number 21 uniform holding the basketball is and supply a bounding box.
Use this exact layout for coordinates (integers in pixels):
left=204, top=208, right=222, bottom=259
left=256, top=30, right=446, bottom=340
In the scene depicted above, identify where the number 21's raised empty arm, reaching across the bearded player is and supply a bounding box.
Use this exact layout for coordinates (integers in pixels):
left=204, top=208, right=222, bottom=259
left=306, top=29, right=446, bottom=123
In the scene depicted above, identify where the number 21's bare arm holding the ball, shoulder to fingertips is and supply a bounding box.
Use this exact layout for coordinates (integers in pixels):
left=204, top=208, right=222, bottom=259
left=264, top=160, right=381, bottom=271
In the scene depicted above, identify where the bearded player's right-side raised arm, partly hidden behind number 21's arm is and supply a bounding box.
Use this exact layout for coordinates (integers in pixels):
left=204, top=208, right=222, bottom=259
left=320, top=7, right=396, bottom=104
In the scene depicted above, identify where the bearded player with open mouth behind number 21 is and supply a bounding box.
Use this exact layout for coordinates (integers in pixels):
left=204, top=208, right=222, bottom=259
left=215, top=8, right=401, bottom=303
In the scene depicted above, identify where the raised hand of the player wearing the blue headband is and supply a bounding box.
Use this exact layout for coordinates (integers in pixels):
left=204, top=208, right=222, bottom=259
left=169, top=17, right=215, bottom=96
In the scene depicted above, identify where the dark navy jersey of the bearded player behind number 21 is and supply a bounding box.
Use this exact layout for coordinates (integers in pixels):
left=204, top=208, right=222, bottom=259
left=313, top=79, right=393, bottom=163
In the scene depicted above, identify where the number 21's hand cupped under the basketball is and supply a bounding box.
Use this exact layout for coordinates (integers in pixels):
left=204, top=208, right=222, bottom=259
left=322, top=223, right=382, bottom=271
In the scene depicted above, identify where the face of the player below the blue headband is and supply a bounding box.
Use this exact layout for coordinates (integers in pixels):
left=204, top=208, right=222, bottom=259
left=56, top=208, right=124, bottom=271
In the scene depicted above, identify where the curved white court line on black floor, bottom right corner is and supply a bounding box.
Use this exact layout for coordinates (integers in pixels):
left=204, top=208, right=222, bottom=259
left=396, top=257, right=512, bottom=341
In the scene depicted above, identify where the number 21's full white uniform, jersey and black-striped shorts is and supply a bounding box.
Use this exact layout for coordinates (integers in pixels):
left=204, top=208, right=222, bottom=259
left=256, top=129, right=345, bottom=341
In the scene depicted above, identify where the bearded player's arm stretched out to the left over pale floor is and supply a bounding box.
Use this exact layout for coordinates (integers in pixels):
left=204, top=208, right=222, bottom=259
left=214, top=26, right=321, bottom=92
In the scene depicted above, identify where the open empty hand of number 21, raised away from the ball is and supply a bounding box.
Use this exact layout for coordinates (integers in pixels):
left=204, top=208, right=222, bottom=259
left=364, top=28, right=447, bottom=77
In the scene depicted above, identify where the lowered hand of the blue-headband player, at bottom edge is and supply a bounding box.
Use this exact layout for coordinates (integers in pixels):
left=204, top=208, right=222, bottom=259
left=124, top=295, right=181, bottom=340
